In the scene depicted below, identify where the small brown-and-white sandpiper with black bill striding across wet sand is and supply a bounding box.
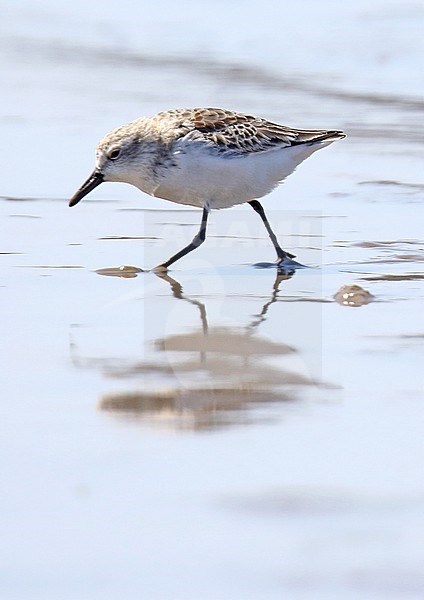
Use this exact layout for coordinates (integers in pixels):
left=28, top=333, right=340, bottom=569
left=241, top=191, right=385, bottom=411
left=69, top=108, right=345, bottom=271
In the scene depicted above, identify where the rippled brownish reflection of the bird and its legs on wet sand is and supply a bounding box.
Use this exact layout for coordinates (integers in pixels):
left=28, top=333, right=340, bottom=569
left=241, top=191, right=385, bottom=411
left=90, top=271, right=317, bottom=431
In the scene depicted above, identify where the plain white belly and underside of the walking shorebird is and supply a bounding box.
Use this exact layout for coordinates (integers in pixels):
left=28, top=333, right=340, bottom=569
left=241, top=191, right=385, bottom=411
left=153, top=144, right=324, bottom=208
